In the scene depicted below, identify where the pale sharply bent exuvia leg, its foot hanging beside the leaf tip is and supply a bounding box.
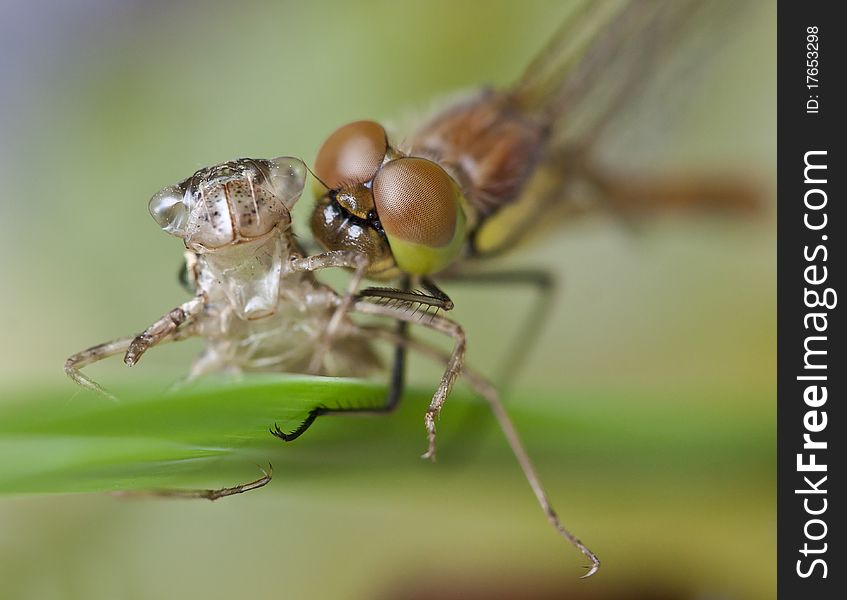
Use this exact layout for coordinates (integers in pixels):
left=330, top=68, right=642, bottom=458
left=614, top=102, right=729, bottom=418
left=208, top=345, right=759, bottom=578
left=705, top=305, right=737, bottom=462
left=353, top=300, right=467, bottom=461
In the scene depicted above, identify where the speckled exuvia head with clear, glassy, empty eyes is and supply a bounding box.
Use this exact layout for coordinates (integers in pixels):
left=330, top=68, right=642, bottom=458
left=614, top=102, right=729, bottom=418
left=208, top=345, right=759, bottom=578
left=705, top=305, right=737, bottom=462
left=149, top=156, right=307, bottom=253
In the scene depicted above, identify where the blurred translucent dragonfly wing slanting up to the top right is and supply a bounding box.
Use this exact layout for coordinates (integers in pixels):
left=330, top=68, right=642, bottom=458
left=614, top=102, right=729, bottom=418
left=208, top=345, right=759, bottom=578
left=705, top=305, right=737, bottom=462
left=510, top=0, right=745, bottom=149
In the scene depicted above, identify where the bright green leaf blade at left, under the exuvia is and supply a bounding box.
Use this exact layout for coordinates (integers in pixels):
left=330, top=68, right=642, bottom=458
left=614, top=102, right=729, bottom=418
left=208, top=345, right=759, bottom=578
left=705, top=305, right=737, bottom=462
left=0, top=375, right=385, bottom=493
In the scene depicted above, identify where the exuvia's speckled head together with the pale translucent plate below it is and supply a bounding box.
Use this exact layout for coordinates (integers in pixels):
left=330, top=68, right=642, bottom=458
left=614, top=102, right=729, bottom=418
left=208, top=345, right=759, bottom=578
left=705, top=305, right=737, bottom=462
left=150, top=157, right=307, bottom=320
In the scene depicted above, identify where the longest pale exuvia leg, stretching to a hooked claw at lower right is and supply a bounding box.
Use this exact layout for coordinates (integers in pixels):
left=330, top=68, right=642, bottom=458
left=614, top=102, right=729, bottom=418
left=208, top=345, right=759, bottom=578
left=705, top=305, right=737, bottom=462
left=363, top=326, right=600, bottom=578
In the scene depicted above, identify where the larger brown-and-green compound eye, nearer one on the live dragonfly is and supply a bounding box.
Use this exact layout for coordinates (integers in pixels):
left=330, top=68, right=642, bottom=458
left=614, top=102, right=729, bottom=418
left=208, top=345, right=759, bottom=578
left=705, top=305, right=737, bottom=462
left=373, top=157, right=465, bottom=275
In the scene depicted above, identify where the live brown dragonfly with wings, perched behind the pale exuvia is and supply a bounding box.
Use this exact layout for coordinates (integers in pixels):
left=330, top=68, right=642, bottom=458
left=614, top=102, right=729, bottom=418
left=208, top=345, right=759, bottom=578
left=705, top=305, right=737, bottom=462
left=310, top=0, right=757, bottom=457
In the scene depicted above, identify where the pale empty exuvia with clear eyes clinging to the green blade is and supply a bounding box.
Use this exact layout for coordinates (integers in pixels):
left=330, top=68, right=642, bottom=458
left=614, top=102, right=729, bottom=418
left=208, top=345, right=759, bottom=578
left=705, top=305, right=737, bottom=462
left=65, top=157, right=600, bottom=575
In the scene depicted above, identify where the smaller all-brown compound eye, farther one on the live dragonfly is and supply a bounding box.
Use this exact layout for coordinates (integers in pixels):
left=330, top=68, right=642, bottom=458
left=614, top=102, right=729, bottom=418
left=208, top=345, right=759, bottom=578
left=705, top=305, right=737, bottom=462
left=315, top=121, right=388, bottom=189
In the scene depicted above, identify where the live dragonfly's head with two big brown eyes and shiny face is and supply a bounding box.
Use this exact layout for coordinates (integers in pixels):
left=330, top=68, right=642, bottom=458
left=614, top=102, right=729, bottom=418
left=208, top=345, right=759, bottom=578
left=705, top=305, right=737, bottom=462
left=311, top=121, right=466, bottom=278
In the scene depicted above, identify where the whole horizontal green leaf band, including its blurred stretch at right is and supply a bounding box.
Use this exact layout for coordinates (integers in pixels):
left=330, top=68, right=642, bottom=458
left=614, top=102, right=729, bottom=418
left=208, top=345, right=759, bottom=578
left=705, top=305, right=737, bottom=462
left=0, top=375, right=774, bottom=493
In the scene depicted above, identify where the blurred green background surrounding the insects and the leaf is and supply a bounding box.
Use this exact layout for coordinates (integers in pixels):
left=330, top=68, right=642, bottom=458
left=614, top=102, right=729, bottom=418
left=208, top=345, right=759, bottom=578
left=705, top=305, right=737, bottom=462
left=0, top=0, right=776, bottom=599
